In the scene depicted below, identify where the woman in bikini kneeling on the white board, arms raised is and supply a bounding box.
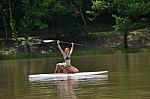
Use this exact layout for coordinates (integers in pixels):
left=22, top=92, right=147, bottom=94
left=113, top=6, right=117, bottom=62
left=55, top=40, right=79, bottom=73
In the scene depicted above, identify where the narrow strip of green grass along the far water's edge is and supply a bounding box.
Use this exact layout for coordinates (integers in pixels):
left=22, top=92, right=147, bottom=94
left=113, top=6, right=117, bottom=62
left=0, top=48, right=150, bottom=60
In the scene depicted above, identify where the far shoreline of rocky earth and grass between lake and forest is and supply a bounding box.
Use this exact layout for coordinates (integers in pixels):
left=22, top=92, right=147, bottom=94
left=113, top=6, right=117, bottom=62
left=0, top=29, right=150, bottom=61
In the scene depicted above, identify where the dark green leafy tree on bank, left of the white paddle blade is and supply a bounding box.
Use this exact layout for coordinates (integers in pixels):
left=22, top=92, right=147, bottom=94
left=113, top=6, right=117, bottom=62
left=20, top=0, right=51, bottom=52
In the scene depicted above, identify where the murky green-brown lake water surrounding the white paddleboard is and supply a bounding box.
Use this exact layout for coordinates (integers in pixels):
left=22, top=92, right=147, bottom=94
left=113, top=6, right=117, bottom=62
left=0, top=53, right=150, bottom=99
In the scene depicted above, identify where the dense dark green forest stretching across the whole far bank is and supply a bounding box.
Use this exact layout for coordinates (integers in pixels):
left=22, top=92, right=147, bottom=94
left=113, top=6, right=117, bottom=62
left=0, top=0, right=150, bottom=53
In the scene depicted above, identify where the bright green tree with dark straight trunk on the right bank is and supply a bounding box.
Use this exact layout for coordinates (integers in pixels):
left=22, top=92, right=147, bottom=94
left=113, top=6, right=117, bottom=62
left=112, top=0, right=150, bottom=48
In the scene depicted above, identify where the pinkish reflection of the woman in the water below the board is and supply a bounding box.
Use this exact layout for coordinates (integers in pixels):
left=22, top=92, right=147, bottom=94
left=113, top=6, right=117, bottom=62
left=56, top=79, right=78, bottom=99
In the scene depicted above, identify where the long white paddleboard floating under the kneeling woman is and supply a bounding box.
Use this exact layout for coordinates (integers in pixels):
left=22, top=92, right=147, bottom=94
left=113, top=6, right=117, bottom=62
left=29, top=71, right=108, bottom=81
